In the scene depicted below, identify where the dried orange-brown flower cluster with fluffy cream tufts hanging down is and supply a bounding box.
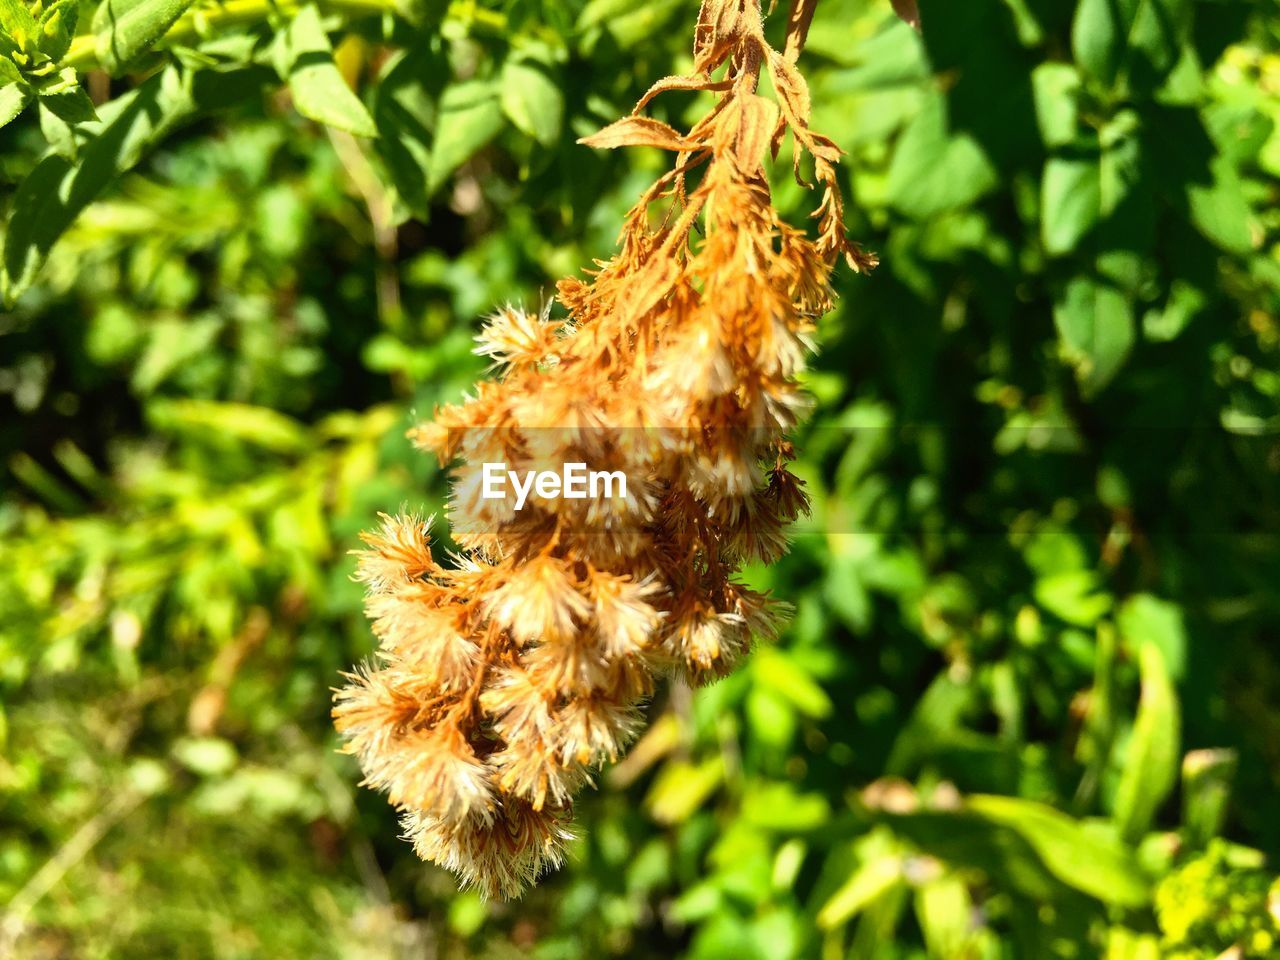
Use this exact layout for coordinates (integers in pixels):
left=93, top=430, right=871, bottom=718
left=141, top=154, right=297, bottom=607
left=334, top=0, right=874, bottom=896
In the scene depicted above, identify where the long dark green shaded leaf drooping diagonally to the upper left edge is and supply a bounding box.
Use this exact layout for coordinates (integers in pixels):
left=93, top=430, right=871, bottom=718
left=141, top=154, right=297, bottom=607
left=0, top=67, right=265, bottom=303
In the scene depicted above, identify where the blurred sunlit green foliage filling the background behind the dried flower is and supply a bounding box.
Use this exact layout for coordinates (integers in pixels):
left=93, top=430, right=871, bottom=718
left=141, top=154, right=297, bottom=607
left=0, top=0, right=1280, bottom=960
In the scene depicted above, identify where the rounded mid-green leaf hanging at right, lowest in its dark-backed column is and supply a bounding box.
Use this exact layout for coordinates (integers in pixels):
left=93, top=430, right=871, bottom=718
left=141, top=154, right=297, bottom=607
left=1053, top=276, right=1134, bottom=398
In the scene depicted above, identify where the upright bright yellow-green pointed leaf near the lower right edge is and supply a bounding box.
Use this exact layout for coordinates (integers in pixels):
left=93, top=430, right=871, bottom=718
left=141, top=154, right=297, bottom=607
left=1115, top=641, right=1180, bottom=841
